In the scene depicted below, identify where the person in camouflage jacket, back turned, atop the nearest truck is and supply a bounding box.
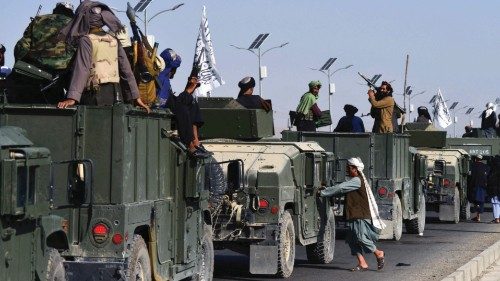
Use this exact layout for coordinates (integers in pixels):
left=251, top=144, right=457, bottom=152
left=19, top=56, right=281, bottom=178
left=8, top=2, right=75, bottom=104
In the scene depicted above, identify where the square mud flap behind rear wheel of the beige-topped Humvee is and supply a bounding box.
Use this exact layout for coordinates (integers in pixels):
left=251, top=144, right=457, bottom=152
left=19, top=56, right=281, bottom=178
left=250, top=245, right=278, bottom=274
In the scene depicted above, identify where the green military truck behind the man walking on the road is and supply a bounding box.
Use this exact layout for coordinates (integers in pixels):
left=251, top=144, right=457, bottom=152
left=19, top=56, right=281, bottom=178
left=281, top=131, right=425, bottom=240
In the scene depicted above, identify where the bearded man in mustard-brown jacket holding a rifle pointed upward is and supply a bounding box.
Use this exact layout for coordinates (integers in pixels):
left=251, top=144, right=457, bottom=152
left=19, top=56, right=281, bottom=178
left=368, top=81, right=394, bottom=133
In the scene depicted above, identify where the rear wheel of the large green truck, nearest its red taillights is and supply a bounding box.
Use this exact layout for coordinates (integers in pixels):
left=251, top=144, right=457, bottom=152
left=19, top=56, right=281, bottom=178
left=127, top=234, right=151, bottom=281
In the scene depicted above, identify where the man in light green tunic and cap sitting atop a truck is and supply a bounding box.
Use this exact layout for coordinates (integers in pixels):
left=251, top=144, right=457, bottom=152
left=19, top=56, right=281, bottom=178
left=295, top=80, right=321, bottom=132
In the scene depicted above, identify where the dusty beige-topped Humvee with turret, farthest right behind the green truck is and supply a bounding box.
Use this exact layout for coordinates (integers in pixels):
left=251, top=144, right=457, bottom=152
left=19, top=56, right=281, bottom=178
left=406, top=123, right=470, bottom=223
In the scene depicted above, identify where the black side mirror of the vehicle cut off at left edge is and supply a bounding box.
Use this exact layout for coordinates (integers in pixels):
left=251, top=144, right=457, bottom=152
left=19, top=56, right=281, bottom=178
left=67, top=161, right=92, bottom=205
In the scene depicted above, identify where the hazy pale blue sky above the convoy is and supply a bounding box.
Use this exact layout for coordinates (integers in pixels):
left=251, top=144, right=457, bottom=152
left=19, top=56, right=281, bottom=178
left=0, top=0, right=500, bottom=135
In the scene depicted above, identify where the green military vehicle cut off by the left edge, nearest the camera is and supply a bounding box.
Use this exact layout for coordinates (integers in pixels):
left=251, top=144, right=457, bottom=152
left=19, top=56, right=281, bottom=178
left=0, top=126, right=83, bottom=281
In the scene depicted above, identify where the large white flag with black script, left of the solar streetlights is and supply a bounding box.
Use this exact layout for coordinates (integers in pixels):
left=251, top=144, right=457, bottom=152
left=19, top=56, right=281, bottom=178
left=194, top=6, right=224, bottom=97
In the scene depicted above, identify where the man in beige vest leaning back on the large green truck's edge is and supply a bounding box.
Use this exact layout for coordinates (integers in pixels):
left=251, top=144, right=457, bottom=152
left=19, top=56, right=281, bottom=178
left=57, top=1, right=149, bottom=112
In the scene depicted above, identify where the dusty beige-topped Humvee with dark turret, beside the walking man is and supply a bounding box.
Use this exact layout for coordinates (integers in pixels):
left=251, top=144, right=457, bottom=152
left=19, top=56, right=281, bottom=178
left=199, top=98, right=335, bottom=278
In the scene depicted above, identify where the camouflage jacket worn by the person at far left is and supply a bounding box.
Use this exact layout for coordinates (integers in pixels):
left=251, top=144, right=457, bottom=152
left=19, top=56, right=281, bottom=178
left=14, top=14, right=75, bottom=70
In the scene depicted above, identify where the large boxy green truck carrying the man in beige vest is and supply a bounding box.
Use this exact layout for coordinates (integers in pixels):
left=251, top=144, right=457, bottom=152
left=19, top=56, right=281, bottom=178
left=0, top=105, right=213, bottom=280
